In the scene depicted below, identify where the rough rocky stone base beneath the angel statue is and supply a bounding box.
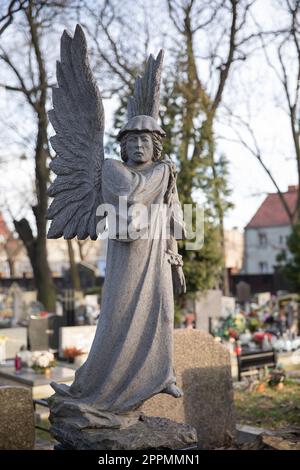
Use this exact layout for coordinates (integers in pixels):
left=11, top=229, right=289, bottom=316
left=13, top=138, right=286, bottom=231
left=51, top=416, right=197, bottom=450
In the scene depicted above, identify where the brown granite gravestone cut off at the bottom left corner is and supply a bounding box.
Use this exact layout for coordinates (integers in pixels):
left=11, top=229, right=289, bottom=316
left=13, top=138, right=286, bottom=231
left=0, top=386, right=35, bottom=450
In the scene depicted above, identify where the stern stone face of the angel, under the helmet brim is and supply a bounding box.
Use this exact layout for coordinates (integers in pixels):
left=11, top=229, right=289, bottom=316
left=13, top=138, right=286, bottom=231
left=126, top=132, right=153, bottom=166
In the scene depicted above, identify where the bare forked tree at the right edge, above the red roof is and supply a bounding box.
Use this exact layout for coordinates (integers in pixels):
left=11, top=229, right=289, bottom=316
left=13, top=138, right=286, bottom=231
left=229, top=0, right=300, bottom=225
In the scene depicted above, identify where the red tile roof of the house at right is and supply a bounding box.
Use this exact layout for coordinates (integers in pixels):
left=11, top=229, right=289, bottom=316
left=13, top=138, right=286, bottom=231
left=246, top=186, right=298, bottom=229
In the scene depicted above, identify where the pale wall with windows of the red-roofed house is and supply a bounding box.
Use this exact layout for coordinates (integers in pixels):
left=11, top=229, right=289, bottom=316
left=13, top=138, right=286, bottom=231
left=243, top=226, right=291, bottom=274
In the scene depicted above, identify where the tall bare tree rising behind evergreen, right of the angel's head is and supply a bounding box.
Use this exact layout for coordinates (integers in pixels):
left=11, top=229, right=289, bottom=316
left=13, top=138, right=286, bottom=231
left=167, top=0, right=254, bottom=295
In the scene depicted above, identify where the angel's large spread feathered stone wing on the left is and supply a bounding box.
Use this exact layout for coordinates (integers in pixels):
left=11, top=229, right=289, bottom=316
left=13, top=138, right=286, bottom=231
left=47, top=25, right=104, bottom=240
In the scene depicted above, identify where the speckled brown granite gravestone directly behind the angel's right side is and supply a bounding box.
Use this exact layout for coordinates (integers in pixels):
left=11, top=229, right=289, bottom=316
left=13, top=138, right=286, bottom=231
left=141, top=329, right=235, bottom=448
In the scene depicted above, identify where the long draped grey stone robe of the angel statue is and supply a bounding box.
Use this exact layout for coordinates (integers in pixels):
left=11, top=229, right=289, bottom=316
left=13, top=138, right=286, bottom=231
left=53, top=159, right=175, bottom=413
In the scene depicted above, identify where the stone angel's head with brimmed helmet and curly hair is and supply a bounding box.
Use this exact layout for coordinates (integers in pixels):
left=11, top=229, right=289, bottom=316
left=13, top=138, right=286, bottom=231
left=118, top=115, right=165, bottom=165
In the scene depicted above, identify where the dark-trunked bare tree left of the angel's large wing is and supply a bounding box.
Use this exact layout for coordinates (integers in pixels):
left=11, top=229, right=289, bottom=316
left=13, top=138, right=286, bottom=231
left=0, top=0, right=68, bottom=311
